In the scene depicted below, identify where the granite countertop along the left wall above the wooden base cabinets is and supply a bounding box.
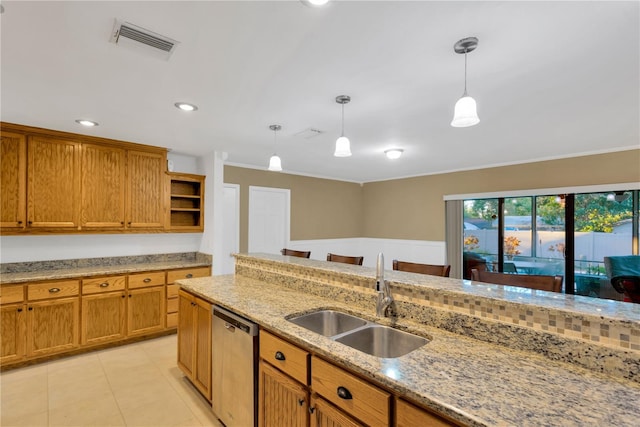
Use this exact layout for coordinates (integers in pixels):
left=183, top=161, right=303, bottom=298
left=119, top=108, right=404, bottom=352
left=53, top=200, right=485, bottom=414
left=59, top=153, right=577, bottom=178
left=0, top=260, right=211, bottom=285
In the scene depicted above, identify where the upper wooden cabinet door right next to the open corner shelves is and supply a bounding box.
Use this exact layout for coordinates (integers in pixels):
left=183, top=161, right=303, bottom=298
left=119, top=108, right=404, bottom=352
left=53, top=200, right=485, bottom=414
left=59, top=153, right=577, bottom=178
left=127, top=151, right=166, bottom=228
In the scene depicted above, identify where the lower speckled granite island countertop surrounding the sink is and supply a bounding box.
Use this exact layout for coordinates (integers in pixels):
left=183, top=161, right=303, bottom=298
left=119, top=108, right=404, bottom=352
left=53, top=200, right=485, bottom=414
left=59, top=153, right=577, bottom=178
left=178, top=275, right=640, bottom=426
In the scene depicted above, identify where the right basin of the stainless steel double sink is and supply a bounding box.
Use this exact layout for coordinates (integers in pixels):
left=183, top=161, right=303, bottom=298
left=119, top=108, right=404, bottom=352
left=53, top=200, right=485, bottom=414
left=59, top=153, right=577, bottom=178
left=336, top=324, right=429, bottom=358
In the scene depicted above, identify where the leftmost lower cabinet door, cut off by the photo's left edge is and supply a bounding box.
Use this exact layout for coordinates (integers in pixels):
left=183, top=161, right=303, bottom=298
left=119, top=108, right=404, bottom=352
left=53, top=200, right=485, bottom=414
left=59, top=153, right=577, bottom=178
left=0, top=303, right=25, bottom=364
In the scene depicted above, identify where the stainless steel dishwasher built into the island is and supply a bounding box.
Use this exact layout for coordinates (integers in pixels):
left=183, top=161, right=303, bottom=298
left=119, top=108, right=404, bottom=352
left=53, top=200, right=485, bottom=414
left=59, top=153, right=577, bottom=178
left=211, top=306, right=258, bottom=427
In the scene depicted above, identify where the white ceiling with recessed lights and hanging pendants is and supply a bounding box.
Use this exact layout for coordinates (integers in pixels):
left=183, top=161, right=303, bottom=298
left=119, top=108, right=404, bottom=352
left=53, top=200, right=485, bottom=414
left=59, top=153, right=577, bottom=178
left=1, top=0, right=640, bottom=182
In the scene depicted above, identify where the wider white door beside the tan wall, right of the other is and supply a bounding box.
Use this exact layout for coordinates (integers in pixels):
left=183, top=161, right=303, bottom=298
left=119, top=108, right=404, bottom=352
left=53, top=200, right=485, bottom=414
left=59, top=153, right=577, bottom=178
left=249, top=187, right=291, bottom=254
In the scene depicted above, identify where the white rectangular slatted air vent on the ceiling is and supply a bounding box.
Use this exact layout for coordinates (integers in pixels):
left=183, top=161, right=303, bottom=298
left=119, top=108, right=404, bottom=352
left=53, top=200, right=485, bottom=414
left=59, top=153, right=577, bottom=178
left=109, top=19, right=179, bottom=59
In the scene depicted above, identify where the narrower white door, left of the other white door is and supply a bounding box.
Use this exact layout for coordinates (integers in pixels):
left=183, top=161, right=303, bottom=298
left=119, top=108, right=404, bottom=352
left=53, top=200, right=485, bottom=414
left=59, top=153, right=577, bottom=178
left=219, top=184, right=240, bottom=274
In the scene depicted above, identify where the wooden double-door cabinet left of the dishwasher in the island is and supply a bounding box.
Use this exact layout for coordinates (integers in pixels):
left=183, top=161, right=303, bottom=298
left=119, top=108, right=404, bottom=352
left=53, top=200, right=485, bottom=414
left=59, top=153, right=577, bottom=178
left=178, top=290, right=212, bottom=401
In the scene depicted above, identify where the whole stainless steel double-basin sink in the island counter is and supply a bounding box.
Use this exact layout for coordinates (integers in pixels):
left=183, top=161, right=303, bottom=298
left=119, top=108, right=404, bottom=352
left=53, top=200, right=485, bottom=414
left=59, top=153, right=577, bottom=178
left=288, top=310, right=429, bottom=358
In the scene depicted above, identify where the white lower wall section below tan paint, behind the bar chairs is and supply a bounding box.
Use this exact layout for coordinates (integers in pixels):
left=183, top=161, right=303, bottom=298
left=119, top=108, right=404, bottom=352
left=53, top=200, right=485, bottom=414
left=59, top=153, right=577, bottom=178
left=287, top=237, right=446, bottom=270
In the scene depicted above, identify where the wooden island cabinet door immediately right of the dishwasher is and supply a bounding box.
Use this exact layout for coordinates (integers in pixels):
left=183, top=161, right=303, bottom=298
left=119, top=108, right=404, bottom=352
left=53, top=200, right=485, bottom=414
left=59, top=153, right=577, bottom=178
left=258, top=360, right=309, bottom=427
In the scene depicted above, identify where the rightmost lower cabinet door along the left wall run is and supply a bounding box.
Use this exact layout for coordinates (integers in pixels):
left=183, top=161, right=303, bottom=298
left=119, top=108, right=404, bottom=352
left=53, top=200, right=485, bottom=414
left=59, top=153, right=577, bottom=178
left=127, top=285, right=166, bottom=335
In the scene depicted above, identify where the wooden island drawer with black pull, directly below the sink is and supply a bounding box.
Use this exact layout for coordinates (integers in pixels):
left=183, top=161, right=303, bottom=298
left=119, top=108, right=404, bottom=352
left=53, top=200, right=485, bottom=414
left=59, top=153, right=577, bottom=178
left=311, top=356, right=391, bottom=426
